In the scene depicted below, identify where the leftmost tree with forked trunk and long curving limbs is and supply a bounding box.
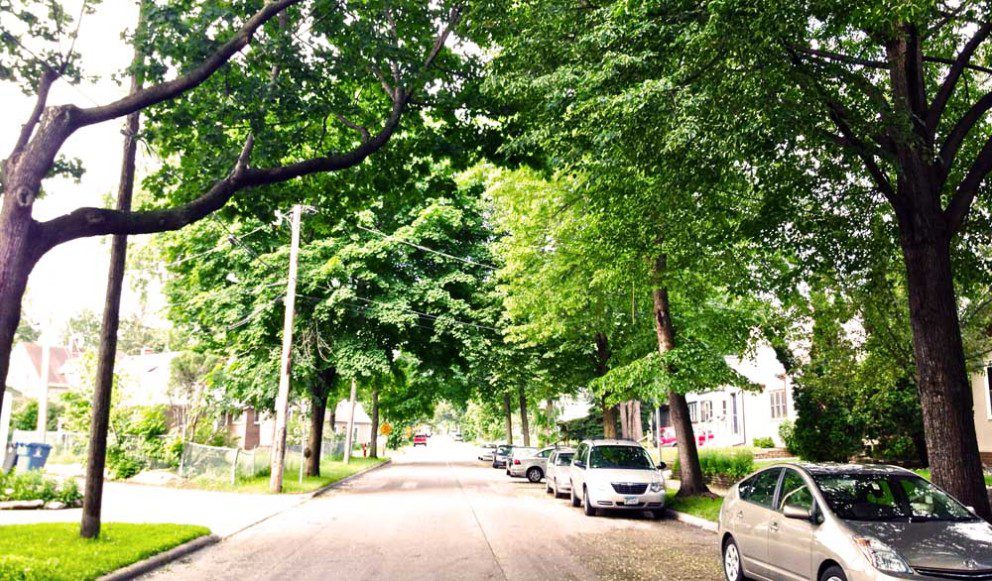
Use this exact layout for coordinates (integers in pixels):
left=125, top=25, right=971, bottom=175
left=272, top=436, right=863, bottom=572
left=0, top=0, right=461, bottom=426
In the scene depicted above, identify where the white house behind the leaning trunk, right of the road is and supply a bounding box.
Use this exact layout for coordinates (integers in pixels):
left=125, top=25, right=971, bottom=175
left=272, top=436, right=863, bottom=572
left=680, top=346, right=796, bottom=447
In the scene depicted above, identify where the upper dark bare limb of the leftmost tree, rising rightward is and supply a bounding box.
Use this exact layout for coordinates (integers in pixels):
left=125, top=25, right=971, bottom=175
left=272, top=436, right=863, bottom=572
left=73, top=0, right=302, bottom=128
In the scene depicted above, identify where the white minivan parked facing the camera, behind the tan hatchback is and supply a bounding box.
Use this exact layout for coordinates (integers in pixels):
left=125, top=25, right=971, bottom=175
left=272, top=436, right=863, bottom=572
left=568, top=440, right=665, bottom=518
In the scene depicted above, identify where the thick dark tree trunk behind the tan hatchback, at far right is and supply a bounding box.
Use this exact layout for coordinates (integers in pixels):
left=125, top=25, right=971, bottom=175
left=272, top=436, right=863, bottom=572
left=902, top=233, right=992, bottom=520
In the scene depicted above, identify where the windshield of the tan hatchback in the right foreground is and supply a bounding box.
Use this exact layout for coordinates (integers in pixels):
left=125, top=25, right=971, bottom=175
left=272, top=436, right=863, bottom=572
left=813, top=473, right=975, bottom=522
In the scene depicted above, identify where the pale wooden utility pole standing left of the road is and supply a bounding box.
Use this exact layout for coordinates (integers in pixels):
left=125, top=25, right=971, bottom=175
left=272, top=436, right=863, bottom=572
left=269, top=204, right=303, bottom=492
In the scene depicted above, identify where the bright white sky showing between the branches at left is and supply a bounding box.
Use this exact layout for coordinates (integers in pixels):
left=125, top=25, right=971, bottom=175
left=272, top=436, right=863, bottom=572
left=0, top=0, right=164, bottom=341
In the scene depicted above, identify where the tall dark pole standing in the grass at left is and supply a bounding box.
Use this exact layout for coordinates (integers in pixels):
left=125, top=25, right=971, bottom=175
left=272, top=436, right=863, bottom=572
left=79, top=12, right=145, bottom=539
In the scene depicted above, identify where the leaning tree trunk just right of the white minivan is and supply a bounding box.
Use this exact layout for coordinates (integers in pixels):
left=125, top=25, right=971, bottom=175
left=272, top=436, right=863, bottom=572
left=651, top=255, right=709, bottom=495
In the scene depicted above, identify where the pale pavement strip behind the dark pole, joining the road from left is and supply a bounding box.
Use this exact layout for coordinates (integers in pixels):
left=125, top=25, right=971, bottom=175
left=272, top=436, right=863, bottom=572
left=0, top=482, right=302, bottom=538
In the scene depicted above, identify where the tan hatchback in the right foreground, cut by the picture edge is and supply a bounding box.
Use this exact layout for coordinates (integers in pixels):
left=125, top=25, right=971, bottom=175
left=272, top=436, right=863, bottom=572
left=718, top=463, right=992, bottom=581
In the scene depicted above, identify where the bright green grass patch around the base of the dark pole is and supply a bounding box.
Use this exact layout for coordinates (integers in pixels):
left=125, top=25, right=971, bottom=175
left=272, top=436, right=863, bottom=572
left=0, top=523, right=210, bottom=581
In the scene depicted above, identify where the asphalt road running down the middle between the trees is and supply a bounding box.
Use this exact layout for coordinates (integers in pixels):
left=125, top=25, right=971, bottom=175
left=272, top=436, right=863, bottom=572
left=149, top=437, right=722, bottom=581
